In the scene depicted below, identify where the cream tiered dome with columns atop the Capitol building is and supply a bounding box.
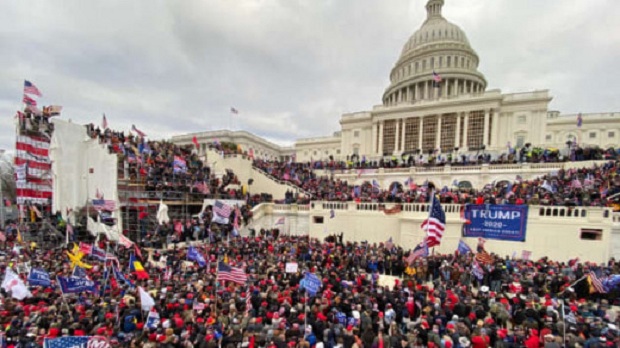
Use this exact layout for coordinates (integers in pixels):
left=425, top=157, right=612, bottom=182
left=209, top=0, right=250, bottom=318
left=383, top=0, right=487, bottom=105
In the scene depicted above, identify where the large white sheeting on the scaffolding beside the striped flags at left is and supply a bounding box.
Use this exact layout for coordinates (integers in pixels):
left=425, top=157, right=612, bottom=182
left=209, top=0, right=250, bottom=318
left=49, top=118, right=122, bottom=231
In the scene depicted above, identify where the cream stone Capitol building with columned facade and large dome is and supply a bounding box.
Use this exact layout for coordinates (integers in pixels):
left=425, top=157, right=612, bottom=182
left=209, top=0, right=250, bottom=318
left=172, top=0, right=620, bottom=161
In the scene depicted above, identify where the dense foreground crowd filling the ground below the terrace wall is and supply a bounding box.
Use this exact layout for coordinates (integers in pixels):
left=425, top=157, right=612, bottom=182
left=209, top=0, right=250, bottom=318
left=0, top=230, right=620, bottom=348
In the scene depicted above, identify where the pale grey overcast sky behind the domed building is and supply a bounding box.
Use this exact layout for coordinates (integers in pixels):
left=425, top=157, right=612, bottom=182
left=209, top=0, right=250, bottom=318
left=0, top=0, right=620, bottom=149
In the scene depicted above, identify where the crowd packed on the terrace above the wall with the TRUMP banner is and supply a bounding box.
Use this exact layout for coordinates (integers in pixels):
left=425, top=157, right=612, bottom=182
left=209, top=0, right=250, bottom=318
left=254, top=160, right=620, bottom=206
